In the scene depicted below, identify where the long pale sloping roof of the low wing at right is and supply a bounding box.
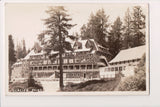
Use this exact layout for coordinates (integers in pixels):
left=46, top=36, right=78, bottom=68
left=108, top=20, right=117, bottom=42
left=109, top=45, right=146, bottom=63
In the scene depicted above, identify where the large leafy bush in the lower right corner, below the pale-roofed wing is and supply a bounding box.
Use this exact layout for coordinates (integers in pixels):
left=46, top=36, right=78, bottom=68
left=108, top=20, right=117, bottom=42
left=118, top=55, right=146, bottom=91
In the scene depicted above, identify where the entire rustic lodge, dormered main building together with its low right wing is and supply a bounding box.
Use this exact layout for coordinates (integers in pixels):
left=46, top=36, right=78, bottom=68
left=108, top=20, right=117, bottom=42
left=11, top=39, right=146, bottom=81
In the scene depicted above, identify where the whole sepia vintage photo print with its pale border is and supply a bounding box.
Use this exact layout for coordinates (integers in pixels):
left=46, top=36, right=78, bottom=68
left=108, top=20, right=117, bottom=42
left=5, top=3, right=149, bottom=95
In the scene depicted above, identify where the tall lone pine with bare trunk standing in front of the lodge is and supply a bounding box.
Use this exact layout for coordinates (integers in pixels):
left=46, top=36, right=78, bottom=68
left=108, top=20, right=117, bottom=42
left=38, top=6, right=74, bottom=90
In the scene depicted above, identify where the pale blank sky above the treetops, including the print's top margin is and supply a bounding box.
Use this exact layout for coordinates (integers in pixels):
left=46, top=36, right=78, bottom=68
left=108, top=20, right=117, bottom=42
left=5, top=3, right=147, bottom=49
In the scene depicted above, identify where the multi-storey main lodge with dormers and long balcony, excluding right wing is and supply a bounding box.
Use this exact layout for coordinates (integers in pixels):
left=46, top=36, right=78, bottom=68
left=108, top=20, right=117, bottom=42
left=11, top=39, right=108, bottom=81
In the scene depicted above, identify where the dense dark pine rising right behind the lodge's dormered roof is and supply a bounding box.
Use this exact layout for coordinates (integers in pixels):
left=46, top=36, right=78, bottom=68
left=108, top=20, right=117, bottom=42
left=81, top=9, right=109, bottom=47
